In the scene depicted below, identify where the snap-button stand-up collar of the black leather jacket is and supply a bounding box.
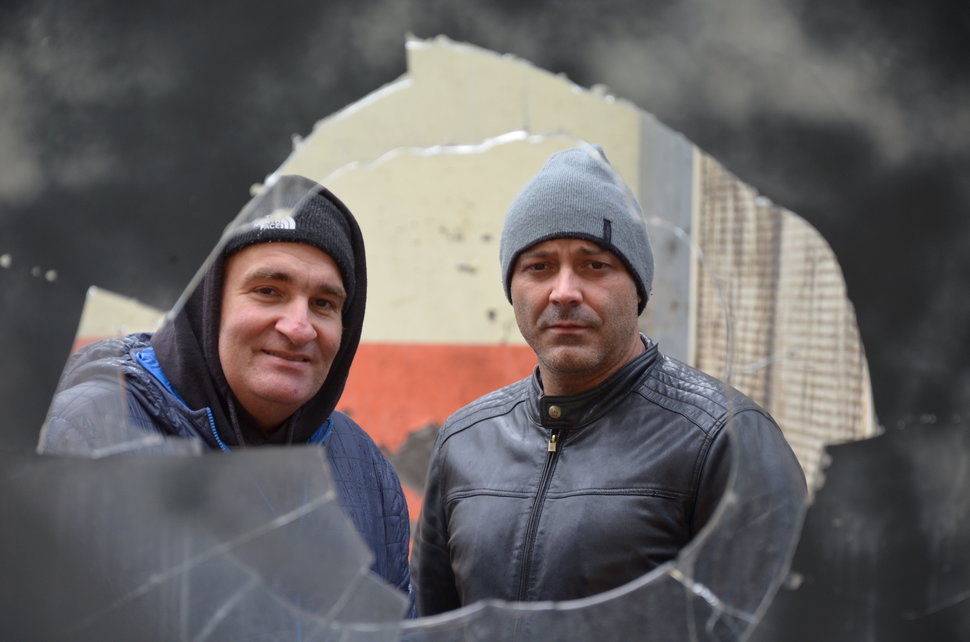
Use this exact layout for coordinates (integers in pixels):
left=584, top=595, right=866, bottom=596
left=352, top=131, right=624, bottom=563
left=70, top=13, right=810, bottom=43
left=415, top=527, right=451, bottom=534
left=528, top=334, right=660, bottom=429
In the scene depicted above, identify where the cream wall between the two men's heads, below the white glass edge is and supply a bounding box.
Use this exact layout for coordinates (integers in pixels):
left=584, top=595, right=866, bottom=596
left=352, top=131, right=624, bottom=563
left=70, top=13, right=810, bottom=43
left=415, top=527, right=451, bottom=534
left=329, top=137, right=570, bottom=344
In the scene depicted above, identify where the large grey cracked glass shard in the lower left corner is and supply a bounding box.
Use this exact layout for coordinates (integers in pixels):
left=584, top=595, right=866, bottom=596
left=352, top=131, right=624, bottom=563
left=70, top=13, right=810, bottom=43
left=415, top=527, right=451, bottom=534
left=0, top=447, right=390, bottom=640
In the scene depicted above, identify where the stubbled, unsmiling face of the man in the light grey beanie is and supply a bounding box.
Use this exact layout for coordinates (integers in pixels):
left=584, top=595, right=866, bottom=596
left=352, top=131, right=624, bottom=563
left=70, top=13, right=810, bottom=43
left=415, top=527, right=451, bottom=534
left=511, top=238, right=643, bottom=394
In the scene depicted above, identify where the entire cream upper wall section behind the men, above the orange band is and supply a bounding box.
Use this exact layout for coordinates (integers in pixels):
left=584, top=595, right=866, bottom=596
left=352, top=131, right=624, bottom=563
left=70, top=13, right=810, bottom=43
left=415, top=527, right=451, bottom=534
left=277, top=38, right=652, bottom=344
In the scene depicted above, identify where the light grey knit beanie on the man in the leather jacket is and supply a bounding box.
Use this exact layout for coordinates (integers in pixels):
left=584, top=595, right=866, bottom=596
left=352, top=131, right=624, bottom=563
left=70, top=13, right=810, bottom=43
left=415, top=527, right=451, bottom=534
left=499, top=145, right=653, bottom=314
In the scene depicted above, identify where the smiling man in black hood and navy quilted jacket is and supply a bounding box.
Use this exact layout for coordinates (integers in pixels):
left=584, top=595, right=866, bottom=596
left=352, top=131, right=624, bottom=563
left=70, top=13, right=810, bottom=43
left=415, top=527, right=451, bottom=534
left=38, top=176, right=410, bottom=604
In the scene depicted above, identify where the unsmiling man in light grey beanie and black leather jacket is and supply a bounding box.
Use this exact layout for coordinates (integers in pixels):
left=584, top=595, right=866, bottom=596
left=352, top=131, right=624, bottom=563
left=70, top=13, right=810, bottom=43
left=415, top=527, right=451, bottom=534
left=412, top=146, right=805, bottom=615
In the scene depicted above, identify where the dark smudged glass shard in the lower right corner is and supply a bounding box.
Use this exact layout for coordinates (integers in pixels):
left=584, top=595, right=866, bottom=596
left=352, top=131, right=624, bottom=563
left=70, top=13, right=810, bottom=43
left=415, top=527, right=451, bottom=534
left=751, top=418, right=970, bottom=642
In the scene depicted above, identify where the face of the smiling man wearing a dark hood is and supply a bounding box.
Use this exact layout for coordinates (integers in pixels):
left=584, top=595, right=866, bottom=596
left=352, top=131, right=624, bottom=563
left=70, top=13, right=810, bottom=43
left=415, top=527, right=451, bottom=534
left=219, top=243, right=346, bottom=430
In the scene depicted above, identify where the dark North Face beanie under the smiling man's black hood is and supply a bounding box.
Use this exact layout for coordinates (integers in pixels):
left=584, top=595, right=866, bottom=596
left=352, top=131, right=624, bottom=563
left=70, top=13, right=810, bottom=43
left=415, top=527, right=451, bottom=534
left=222, top=175, right=357, bottom=302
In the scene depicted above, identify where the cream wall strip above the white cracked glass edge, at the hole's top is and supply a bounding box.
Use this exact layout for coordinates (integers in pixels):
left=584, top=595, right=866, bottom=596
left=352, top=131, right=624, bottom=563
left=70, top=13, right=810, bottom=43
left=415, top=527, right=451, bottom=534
left=276, top=38, right=639, bottom=190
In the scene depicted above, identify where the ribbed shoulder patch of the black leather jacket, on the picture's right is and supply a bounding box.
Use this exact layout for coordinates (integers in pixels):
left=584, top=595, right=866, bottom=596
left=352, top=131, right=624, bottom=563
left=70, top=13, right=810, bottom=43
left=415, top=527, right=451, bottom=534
left=637, top=355, right=767, bottom=432
